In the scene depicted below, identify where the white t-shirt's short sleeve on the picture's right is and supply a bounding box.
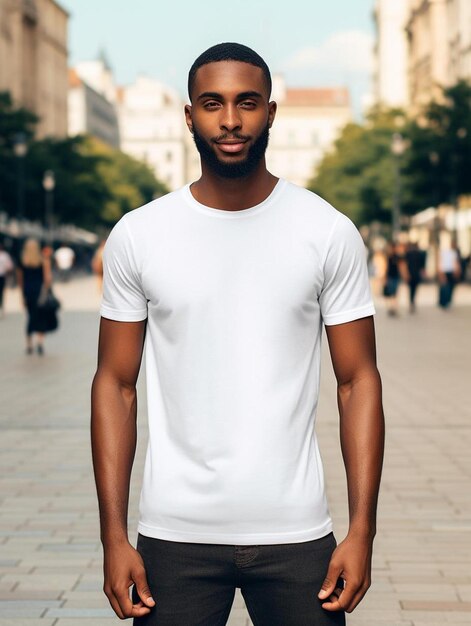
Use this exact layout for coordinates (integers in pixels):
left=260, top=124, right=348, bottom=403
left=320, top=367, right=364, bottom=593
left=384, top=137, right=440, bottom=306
left=319, top=213, right=375, bottom=326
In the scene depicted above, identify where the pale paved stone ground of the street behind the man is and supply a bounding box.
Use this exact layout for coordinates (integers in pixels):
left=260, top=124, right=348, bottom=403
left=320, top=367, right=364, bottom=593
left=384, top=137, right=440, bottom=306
left=0, top=278, right=471, bottom=626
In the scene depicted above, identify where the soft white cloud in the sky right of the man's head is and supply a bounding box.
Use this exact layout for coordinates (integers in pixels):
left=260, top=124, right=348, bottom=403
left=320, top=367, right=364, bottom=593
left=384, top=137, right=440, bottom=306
left=281, top=30, right=374, bottom=74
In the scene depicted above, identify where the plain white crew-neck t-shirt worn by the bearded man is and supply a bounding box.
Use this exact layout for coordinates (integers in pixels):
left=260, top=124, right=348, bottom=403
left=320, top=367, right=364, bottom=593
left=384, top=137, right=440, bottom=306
left=101, top=179, right=374, bottom=545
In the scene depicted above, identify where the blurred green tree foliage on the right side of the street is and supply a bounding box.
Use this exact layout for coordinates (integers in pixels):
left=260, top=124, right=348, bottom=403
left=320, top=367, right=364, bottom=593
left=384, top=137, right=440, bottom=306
left=309, top=81, right=471, bottom=224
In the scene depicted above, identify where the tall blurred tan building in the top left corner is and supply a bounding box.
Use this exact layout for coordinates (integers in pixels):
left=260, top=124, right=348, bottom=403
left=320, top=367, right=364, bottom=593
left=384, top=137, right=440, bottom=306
left=0, top=0, right=69, bottom=138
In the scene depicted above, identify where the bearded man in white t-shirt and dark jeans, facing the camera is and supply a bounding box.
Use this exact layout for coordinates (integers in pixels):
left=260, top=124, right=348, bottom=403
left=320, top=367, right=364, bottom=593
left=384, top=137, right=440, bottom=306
left=92, top=44, right=383, bottom=626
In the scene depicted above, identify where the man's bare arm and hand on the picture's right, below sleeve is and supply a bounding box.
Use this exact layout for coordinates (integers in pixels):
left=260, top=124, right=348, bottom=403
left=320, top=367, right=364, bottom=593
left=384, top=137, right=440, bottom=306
left=319, top=317, right=384, bottom=613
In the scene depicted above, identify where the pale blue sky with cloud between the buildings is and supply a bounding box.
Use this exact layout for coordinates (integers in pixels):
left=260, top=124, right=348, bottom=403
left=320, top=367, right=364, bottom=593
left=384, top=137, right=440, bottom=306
left=58, top=0, right=374, bottom=114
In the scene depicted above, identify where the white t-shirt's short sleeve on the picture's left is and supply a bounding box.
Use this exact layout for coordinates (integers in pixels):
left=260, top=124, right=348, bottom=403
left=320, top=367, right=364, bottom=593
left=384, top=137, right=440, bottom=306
left=100, top=218, right=147, bottom=322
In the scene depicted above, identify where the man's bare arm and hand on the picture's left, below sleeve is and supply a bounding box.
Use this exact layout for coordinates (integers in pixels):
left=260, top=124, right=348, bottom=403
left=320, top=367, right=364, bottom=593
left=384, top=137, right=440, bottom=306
left=91, top=318, right=154, bottom=619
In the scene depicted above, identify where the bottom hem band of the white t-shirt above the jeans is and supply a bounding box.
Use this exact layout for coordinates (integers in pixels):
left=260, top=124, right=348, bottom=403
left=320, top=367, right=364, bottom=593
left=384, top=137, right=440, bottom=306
left=137, top=521, right=332, bottom=545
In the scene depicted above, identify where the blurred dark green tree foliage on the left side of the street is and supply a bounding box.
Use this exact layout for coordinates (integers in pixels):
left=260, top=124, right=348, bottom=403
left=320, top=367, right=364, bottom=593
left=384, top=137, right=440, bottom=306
left=0, top=93, right=167, bottom=230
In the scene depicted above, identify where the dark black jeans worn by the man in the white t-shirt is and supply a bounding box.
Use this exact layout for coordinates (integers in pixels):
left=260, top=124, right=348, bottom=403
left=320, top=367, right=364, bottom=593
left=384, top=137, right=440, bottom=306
left=132, top=533, right=345, bottom=626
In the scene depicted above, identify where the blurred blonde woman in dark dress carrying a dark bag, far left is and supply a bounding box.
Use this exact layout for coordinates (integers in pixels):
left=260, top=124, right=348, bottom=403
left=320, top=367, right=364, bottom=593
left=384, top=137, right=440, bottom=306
left=17, top=239, right=52, bottom=356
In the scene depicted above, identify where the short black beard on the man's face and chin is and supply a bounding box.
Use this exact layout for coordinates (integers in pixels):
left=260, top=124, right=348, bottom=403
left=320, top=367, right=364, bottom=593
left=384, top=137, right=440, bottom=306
left=193, top=124, right=270, bottom=178
